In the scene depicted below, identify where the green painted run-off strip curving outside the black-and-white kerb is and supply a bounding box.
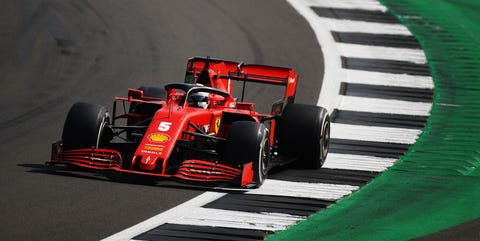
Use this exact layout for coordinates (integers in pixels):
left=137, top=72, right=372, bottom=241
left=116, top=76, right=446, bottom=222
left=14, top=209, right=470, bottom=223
left=267, top=0, right=480, bottom=241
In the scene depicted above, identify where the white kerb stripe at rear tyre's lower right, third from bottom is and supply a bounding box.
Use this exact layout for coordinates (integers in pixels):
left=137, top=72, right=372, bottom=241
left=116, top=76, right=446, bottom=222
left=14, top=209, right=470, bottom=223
left=323, top=153, right=397, bottom=172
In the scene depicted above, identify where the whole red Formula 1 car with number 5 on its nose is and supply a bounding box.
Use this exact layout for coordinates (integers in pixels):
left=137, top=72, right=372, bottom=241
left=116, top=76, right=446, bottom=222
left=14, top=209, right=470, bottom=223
left=49, top=57, right=330, bottom=187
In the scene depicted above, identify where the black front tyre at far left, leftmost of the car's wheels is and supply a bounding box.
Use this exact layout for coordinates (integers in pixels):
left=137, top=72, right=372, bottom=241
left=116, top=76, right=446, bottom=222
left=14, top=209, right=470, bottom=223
left=62, top=102, right=111, bottom=150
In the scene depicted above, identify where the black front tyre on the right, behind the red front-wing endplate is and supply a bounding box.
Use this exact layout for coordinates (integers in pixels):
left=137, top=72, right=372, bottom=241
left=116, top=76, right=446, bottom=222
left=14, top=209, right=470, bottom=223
left=224, top=121, right=270, bottom=187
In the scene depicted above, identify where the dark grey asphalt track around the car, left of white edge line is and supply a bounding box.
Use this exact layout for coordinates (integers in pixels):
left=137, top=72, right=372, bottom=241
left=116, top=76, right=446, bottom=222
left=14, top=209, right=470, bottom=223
left=0, top=0, right=323, bottom=240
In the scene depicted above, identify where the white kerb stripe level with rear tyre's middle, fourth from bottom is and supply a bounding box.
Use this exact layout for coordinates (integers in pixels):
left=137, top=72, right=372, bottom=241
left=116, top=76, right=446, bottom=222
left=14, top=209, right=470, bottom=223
left=331, top=123, right=422, bottom=144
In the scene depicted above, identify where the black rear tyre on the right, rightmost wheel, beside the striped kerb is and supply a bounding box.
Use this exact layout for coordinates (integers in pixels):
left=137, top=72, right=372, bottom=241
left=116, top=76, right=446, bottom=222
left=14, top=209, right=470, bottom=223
left=278, top=104, right=330, bottom=169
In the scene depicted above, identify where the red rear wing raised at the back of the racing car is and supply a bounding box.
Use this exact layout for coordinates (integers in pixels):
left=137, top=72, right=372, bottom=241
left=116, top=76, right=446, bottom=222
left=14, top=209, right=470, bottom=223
left=185, top=57, right=298, bottom=103
